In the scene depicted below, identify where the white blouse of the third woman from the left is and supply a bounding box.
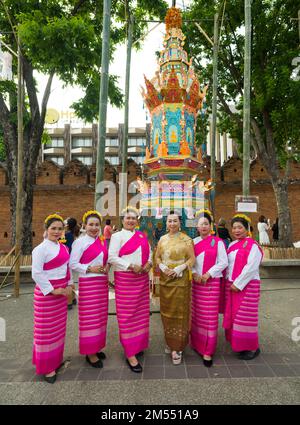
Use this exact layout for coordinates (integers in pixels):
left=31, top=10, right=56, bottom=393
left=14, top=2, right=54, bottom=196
left=108, top=229, right=152, bottom=271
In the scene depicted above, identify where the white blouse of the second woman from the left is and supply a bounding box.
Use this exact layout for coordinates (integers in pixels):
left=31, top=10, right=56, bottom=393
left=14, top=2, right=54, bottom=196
left=70, top=235, right=105, bottom=277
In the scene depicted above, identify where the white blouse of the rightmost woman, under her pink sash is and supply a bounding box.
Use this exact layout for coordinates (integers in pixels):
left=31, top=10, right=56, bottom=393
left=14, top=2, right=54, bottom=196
left=227, top=241, right=262, bottom=291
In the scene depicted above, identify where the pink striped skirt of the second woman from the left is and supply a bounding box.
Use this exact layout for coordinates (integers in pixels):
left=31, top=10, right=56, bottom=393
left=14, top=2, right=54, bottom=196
left=78, top=276, right=108, bottom=355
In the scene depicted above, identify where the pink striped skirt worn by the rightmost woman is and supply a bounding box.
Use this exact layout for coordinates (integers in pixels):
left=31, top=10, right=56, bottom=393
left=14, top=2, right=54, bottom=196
left=223, top=280, right=260, bottom=352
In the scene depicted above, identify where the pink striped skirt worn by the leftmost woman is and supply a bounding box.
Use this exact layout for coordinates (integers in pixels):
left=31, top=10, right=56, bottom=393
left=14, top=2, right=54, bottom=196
left=32, top=278, right=68, bottom=375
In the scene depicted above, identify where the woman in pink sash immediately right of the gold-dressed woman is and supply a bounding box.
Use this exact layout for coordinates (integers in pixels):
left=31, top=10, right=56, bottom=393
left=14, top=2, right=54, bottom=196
left=190, top=210, right=228, bottom=367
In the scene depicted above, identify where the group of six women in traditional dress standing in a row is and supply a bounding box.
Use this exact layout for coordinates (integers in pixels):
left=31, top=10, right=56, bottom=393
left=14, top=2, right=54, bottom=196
left=32, top=207, right=262, bottom=383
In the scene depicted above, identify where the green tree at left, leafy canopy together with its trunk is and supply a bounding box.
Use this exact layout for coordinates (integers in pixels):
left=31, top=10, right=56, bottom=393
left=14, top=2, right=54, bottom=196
left=0, top=0, right=166, bottom=253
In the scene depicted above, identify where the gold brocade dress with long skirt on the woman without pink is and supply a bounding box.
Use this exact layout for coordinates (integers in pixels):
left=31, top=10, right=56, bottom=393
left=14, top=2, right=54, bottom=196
left=155, top=232, right=195, bottom=351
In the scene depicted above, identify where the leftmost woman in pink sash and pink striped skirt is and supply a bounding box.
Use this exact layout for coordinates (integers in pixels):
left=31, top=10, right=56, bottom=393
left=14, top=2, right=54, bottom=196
left=32, top=214, right=72, bottom=384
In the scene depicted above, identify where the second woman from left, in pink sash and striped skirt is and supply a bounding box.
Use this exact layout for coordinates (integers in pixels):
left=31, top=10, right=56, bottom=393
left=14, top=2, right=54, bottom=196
left=70, top=210, right=109, bottom=368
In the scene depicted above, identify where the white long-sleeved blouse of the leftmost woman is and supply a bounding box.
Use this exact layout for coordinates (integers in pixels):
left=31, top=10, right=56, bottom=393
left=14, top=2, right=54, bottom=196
left=31, top=239, right=72, bottom=295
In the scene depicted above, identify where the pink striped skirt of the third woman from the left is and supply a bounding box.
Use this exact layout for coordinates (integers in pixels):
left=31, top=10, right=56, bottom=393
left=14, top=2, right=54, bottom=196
left=115, top=272, right=150, bottom=358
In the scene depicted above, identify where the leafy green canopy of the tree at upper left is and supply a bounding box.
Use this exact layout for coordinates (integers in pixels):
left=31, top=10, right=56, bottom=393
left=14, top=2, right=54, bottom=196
left=0, top=0, right=167, bottom=122
